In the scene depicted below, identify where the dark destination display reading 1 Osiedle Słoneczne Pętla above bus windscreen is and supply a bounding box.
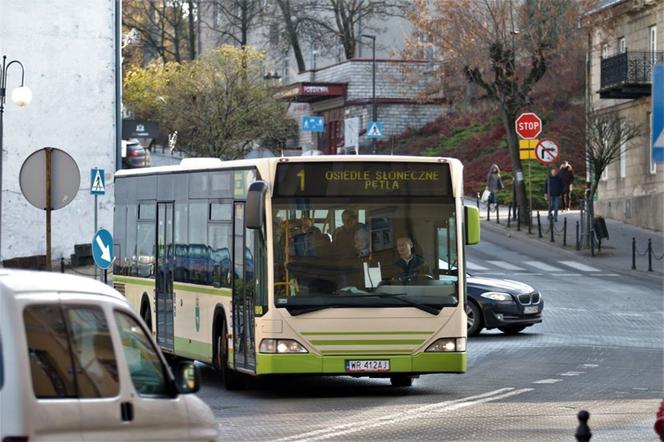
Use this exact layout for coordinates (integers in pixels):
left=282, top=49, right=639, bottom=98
left=274, top=162, right=452, bottom=197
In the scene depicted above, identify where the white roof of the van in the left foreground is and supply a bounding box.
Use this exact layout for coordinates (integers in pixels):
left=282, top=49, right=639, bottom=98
left=0, top=268, right=126, bottom=301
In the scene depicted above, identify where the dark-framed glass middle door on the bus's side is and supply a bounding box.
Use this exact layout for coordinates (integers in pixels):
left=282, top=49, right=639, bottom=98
left=155, top=203, right=175, bottom=352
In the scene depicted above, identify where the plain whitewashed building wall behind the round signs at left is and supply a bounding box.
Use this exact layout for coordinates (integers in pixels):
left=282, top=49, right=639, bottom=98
left=0, top=0, right=120, bottom=260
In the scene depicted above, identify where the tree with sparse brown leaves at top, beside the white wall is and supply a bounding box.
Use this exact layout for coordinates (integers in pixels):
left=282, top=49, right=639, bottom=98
left=122, top=0, right=196, bottom=63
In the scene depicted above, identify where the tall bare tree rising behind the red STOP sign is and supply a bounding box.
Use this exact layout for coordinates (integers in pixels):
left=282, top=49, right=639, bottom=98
left=411, top=0, right=582, bottom=222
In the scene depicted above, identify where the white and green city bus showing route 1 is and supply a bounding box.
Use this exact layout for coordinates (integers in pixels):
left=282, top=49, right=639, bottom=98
left=113, top=156, right=479, bottom=388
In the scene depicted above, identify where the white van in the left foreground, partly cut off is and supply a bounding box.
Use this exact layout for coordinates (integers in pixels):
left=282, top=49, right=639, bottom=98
left=0, top=269, right=219, bottom=442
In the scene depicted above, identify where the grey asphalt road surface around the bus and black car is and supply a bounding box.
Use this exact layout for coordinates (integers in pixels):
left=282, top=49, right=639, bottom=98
left=200, top=229, right=664, bottom=441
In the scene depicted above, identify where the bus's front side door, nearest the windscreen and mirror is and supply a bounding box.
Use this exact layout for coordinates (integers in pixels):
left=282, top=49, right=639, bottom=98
left=233, top=203, right=256, bottom=373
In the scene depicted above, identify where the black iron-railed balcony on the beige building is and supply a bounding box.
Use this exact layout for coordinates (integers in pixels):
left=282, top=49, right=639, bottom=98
left=599, top=52, right=664, bottom=98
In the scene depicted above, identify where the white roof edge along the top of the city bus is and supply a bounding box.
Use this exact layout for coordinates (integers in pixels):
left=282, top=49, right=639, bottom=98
left=115, top=155, right=461, bottom=177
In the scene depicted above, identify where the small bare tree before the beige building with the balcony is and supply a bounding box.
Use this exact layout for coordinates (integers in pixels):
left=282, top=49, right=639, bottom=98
left=586, top=107, right=641, bottom=223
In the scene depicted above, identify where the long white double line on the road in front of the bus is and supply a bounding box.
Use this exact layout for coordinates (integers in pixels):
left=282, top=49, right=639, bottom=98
left=276, top=387, right=533, bottom=442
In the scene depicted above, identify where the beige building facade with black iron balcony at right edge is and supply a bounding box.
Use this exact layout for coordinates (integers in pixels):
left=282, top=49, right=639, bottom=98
left=583, top=0, right=664, bottom=231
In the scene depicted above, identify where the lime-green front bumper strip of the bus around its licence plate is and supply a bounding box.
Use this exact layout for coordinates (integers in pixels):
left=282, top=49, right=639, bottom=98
left=256, top=352, right=466, bottom=376
